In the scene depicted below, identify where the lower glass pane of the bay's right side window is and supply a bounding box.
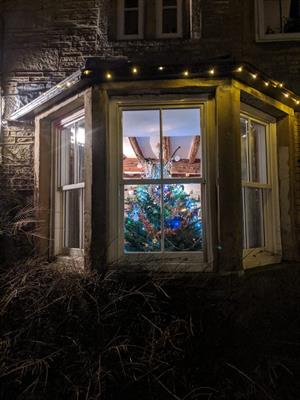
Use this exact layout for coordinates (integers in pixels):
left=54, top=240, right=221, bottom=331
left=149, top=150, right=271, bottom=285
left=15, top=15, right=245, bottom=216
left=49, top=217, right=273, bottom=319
left=244, top=188, right=265, bottom=248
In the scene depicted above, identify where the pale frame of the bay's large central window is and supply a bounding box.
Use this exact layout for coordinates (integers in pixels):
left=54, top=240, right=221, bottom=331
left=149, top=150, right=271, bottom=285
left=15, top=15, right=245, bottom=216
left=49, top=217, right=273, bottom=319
left=108, top=95, right=214, bottom=271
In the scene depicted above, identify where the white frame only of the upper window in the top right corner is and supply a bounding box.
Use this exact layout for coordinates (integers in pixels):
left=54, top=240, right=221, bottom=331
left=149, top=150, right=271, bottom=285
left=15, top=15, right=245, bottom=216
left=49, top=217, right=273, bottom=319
left=255, top=0, right=300, bottom=42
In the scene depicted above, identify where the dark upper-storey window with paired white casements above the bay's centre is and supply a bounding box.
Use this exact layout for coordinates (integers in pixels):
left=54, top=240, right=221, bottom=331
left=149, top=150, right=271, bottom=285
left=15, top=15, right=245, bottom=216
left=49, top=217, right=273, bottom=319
left=117, top=0, right=185, bottom=40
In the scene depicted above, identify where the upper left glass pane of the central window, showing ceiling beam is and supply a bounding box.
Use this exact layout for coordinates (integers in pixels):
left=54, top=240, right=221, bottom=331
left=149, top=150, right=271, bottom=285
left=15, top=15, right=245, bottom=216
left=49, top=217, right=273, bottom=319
left=123, top=110, right=161, bottom=179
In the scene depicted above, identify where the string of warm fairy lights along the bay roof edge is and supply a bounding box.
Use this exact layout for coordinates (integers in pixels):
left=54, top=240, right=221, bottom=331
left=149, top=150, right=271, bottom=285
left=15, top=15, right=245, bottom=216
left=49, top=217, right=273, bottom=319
left=57, top=65, right=300, bottom=105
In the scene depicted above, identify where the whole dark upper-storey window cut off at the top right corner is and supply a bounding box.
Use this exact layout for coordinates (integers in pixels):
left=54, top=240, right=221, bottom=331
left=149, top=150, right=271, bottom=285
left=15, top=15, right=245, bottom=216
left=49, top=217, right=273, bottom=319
left=256, top=0, right=300, bottom=41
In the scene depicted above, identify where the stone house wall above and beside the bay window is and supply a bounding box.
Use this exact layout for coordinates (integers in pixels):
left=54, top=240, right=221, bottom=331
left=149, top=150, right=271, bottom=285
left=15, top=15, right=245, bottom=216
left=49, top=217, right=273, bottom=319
left=0, top=0, right=300, bottom=247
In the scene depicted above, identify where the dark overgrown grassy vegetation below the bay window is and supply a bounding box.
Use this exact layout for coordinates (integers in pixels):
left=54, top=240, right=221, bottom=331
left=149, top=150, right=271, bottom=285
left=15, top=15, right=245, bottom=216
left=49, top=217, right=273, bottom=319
left=0, top=261, right=300, bottom=400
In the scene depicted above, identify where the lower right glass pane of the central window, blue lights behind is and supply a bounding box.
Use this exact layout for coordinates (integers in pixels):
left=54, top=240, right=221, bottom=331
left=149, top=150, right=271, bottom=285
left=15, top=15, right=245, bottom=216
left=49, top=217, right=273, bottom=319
left=163, top=184, right=203, bottom=251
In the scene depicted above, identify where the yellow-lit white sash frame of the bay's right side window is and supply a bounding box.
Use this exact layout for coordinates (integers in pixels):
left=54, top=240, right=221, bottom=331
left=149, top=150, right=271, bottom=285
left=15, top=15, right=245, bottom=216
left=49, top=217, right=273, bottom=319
left=241, top=104, right=282, bottom=269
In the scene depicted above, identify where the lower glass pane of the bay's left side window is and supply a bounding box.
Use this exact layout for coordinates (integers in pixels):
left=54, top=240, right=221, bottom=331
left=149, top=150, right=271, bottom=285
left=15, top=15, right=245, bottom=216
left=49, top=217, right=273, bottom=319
left=64, top=189, right=83, bottom=249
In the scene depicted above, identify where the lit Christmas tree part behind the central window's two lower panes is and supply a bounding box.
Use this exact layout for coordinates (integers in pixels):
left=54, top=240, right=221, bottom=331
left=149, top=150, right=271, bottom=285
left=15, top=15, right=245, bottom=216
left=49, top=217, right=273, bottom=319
left=124, top=184, right=202, bottom=252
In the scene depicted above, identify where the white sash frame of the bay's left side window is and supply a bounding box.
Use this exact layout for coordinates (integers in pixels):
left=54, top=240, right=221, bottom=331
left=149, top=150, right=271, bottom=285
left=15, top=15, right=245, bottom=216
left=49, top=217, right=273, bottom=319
left=50, top=110, right=85, bottom=257
